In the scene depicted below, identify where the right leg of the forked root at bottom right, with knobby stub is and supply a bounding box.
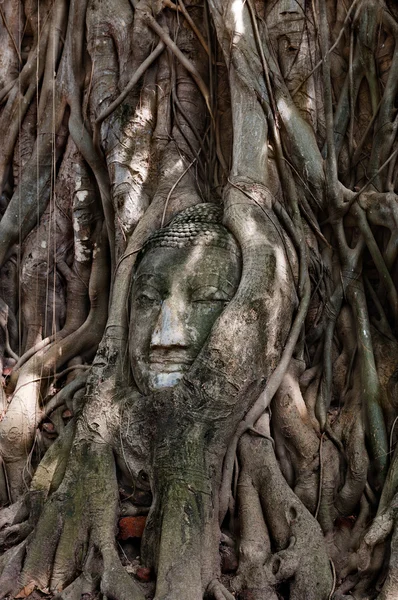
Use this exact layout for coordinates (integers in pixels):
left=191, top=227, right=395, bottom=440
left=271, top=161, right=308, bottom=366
left=239, top=416, right=332, bottom=600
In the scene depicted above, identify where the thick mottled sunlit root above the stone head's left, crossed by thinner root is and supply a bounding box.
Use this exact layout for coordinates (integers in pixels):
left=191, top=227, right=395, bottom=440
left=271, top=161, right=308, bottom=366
left=87, top=1, right=156, bottom=255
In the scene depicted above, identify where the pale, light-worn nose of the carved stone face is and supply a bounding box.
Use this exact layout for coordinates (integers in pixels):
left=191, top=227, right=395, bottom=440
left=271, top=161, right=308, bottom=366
left=151, top=298, right=188, bottom=348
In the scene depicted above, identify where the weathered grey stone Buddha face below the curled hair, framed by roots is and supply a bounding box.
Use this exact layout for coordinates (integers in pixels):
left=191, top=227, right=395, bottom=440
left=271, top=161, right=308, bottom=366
left=129, top=245, right=240, bottom=394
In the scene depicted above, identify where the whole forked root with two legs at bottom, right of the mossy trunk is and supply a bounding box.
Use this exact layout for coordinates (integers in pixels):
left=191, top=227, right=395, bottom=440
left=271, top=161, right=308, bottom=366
left=235, top=412, right=333, bottom=600
